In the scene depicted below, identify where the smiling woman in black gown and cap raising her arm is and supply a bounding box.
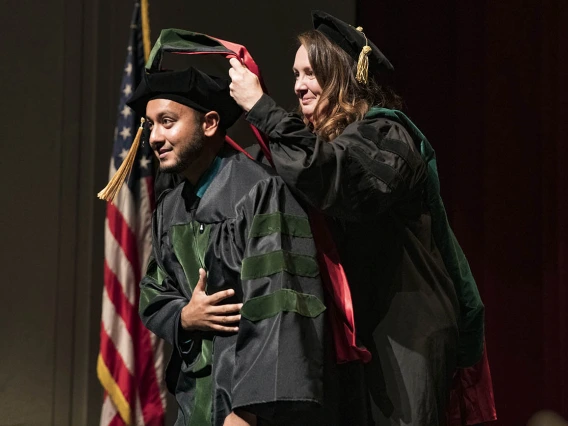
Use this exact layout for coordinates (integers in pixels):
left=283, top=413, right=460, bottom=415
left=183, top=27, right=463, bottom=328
left=229, top=11, right=490, bottom=426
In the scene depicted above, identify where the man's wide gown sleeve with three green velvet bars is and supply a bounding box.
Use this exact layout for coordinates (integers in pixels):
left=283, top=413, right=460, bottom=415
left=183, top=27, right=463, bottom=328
left=226, top=177, right=324, bottom=424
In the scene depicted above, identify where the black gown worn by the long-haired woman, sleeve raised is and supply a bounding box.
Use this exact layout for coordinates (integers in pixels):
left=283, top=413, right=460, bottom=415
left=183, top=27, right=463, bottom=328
left=247, top=95, right=459, bottom=426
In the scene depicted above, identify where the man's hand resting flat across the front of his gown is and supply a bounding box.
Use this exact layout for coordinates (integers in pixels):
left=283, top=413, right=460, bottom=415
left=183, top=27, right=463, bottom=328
left=181, top=268, right=243, bottom=333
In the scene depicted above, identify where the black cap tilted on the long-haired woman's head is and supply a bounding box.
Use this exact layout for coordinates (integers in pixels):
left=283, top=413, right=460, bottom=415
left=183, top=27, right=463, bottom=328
left=312, top=10, right=394, bottom=78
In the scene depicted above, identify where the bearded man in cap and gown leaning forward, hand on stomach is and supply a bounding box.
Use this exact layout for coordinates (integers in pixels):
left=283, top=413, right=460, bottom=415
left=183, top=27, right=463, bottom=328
left=129, top=68, right=329, bottom=426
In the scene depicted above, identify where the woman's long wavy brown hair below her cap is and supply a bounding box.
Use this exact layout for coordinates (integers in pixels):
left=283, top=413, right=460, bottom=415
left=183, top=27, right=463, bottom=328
left=298, top=30, right=402, bottom=141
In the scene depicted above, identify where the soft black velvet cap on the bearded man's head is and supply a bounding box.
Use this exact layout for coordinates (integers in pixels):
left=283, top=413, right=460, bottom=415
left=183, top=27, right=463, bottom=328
left=127, top=67, right=243, bottom=129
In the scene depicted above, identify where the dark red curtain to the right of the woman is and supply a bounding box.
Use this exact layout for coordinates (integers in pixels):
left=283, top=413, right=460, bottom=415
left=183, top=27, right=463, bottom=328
left=357, top=0, right=568, bottom=426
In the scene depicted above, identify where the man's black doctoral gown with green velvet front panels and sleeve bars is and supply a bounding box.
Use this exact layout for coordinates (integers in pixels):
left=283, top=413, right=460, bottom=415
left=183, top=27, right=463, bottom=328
left=140, top=149, right=327, bottom=426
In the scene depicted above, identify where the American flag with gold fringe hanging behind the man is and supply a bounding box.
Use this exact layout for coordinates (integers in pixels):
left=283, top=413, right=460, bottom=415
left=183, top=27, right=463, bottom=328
left=97, top=2, right=165, bottom=426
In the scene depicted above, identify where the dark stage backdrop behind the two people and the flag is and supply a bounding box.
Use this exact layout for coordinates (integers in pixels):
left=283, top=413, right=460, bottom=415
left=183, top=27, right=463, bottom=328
left=0, top=0, right=568, bottom=426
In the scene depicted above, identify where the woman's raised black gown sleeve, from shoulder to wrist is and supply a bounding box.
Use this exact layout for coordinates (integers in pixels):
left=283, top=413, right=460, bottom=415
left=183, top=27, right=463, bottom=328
left=247, top=95, right=426, bottom=220
